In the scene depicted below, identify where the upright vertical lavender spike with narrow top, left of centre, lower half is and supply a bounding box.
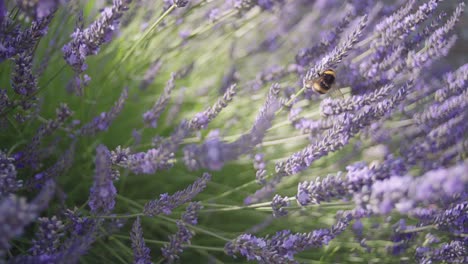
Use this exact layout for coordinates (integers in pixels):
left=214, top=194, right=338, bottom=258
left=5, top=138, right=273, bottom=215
left=88, top=145, right=117, bottom=214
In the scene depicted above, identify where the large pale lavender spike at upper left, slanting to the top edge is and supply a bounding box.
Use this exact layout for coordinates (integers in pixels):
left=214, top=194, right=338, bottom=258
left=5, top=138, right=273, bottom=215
left=62, top=0, right=131, bottom=74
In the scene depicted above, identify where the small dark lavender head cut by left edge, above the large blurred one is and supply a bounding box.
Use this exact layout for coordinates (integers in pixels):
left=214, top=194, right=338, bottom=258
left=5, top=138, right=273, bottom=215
left=0, top=150, right=23, bottom=195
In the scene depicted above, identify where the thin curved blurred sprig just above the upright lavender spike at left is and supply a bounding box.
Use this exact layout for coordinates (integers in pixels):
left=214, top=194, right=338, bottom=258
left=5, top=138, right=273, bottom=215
left=77, top=87, right=128, bottom=136
